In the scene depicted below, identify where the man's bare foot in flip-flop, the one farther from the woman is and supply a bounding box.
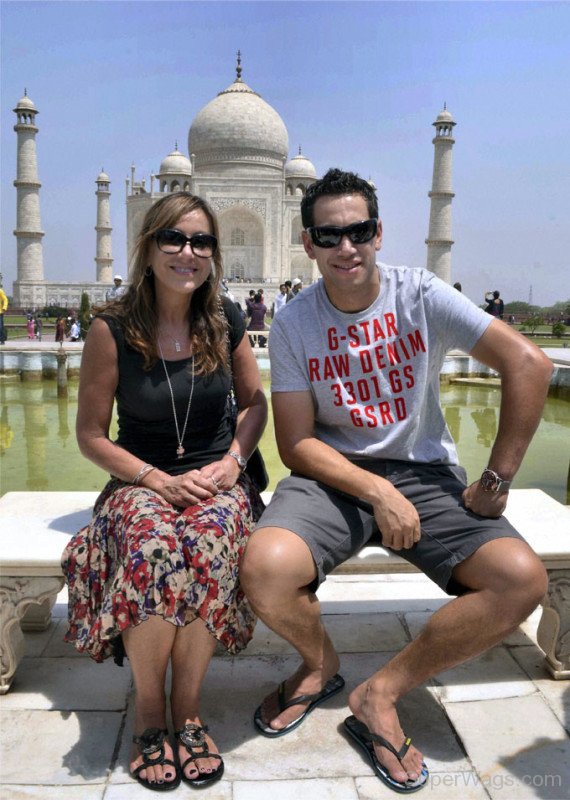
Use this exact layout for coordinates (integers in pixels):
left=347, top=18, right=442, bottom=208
left=348, top=683, right=424, bottom=784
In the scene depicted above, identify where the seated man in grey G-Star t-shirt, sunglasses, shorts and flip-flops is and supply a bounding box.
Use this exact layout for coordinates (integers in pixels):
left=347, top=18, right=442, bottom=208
left=241, top=170, right=552, bottom=791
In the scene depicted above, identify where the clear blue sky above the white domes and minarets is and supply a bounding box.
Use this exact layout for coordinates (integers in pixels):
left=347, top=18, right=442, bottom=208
left=0, top=0, right=570, bottom=306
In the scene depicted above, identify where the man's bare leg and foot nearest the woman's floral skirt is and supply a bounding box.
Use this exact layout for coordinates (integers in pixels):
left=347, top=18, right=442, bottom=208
left=240, top=528, right=340, bottom=730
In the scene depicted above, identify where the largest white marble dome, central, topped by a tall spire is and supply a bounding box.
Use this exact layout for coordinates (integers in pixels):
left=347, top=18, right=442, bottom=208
left=188, top=75, right=289, bottom=170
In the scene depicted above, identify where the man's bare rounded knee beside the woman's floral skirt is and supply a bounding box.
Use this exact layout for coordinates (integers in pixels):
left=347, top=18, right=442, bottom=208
left=240, top=528, right=316, bottom=596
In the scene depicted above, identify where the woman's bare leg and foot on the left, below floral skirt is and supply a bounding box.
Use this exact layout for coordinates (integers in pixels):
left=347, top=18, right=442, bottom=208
left=122, top=616, right=177, bottom=783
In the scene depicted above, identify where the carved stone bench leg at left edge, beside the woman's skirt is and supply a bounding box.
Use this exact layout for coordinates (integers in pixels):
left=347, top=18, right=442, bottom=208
left=0, top=576, right=63, bottom=694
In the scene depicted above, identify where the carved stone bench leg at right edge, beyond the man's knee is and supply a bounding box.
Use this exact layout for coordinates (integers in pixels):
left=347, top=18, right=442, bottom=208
left=537, top=569, right=570, bottom=680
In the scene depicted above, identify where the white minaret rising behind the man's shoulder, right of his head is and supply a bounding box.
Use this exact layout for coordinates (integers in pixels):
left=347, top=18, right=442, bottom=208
left=426, top=105, right=456, bottom=283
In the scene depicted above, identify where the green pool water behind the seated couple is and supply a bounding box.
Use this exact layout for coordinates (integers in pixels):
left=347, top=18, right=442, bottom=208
left=0, top=381, right=570, bottom=503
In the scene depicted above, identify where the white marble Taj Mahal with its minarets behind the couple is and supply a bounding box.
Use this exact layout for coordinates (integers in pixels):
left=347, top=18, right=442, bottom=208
left=13, top=52, right=455, bottom=308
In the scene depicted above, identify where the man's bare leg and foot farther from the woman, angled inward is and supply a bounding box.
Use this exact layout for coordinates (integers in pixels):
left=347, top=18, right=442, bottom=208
left=349, top=538, right=548, bottom=782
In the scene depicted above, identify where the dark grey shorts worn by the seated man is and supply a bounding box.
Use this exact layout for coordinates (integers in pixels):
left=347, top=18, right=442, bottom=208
left=257, top=459, right=524, bottom=595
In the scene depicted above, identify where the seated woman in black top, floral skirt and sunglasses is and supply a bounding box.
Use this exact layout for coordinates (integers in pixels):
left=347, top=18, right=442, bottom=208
left=63, top=192, right=267, bottom=791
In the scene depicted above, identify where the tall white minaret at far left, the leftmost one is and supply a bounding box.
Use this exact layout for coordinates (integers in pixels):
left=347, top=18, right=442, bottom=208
left=13, top=90, right=44, bottom=305
